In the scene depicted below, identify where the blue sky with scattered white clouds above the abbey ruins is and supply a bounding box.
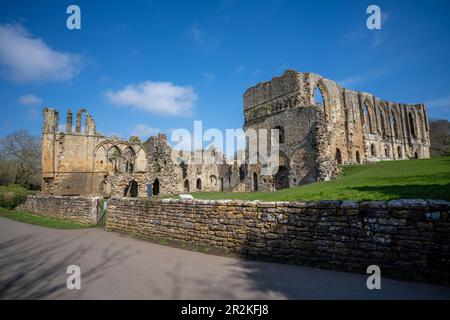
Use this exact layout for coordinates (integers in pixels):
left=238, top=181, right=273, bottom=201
left=0, top=0, right=450, bottom=145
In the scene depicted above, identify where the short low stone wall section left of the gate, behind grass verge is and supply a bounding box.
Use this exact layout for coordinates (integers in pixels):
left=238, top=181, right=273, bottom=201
left=17, top=195, right=100, bottom=224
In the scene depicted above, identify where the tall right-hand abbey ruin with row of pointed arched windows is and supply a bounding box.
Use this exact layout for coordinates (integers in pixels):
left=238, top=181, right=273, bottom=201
left=244, top=70, right=430, bottom=191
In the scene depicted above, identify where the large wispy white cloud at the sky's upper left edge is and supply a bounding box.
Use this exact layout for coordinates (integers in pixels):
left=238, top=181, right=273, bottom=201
left=0, top=24, right=81, bottom=82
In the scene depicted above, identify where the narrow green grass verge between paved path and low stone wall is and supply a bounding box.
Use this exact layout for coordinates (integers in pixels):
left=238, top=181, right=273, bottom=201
left=0, top=207, right=96, bottom=229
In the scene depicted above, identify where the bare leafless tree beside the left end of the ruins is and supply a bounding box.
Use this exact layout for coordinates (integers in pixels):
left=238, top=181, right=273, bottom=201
left=0, top=130, right=41, bottom=188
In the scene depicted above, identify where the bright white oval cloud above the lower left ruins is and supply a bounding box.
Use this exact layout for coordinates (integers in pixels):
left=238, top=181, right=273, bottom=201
left=105, top=81, right=198, bottom=116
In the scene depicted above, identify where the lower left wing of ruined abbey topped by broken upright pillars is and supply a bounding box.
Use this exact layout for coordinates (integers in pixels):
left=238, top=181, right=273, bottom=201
left=42, top=108, right=236, bottom=197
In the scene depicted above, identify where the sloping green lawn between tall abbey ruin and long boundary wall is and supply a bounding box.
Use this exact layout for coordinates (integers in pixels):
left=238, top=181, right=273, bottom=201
left=192, top=157, right=450, bottom=201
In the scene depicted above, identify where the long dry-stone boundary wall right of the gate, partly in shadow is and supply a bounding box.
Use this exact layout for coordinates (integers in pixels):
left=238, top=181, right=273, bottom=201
left=107, top=198, right=450, bottom=284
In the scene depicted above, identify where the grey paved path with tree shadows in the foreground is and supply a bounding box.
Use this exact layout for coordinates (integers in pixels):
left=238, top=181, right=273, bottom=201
left=0, top=218, right=450, bottom=299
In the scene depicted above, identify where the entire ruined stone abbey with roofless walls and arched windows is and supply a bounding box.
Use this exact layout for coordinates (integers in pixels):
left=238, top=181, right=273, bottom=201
left=42, top=70, right=430, bottom=197
